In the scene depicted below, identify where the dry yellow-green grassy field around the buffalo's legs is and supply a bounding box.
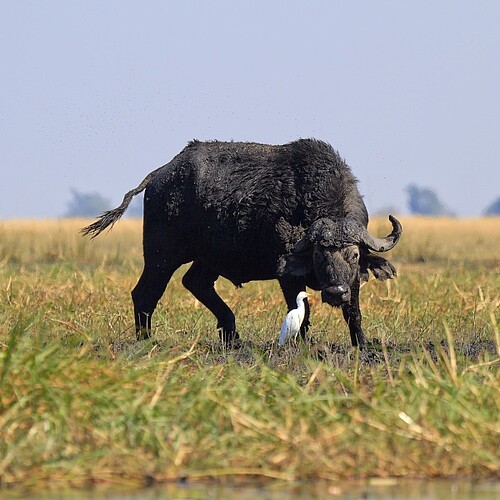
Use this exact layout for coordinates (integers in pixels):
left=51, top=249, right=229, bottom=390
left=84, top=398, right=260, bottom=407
left=0, top=218, right=500, bottom=488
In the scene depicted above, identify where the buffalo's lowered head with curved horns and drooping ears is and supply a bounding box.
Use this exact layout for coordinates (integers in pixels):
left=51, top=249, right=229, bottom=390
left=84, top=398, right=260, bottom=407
left=278, top=215, right=402, bottom=306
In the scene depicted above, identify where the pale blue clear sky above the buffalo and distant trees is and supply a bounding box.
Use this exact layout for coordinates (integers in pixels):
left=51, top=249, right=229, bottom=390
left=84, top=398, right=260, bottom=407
left=0, top=0, right=500, bottom=218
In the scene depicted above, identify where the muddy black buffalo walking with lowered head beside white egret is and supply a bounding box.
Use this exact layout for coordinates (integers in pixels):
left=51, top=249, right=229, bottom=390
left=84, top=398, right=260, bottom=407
left=82, top=139, right=402, bottom=346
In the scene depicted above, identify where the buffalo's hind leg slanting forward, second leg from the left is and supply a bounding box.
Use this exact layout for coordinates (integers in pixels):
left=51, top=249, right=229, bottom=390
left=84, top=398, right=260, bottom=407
left=182, top=260, right=239, bottom=346
